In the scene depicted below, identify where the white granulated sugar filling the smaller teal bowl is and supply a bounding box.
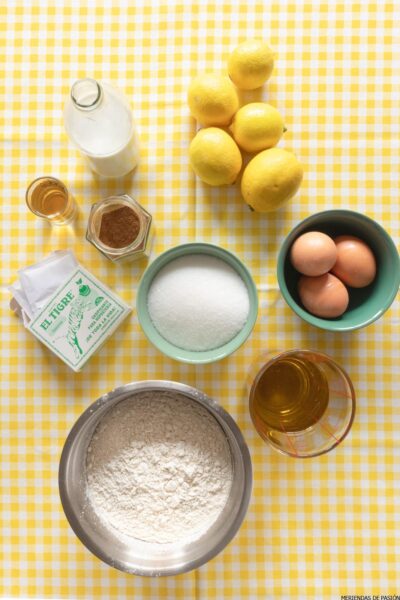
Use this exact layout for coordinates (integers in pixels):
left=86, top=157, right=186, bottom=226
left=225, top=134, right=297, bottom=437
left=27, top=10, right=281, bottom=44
left=147, top=254, right=250, bottom=351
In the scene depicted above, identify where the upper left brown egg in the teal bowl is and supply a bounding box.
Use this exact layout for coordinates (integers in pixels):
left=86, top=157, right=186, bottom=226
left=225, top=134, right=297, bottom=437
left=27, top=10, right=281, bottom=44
left=290, top=231, right=337, bottom=276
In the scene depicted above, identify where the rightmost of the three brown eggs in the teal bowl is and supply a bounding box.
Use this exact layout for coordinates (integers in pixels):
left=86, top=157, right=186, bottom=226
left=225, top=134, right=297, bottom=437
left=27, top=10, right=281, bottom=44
left=332, top=235, right=376, bottom=288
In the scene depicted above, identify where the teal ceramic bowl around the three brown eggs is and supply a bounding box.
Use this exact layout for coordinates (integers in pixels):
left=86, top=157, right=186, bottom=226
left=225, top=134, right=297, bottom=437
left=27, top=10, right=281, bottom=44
left=277, top=210, right=400, bottom=331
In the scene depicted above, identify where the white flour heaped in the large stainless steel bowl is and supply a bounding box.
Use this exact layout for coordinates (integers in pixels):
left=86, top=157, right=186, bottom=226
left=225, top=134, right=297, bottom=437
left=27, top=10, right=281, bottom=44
left=86, top=392, right=232, bottom=543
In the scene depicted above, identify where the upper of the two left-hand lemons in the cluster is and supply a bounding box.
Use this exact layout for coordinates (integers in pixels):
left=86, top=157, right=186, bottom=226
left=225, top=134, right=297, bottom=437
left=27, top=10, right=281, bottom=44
left=188, top=73, right=239, bottom=127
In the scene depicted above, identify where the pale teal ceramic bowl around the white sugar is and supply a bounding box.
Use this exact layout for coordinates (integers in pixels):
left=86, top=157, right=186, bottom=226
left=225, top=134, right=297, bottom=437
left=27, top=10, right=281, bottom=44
left=136, top=243, right=258, bottom=364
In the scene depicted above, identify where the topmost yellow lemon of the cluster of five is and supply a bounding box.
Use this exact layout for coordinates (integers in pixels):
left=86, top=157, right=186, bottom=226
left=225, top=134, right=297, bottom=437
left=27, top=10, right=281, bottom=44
left=228, top=40, right=274, bottom=90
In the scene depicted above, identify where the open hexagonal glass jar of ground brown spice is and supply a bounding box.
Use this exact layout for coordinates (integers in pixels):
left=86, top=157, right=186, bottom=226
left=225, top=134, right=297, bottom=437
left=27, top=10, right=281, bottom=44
left=86, top=194, right=153, bottom=262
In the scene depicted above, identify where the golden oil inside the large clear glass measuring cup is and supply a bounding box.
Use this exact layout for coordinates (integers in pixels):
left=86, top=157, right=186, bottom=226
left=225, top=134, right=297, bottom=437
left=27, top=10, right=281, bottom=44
left=252, top=356, right=329, bottom=434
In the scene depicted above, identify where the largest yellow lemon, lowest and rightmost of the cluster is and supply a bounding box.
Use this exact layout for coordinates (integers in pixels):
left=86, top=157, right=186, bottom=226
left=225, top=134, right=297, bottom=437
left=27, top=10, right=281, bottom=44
left=242, top=148, right=303, bottom=212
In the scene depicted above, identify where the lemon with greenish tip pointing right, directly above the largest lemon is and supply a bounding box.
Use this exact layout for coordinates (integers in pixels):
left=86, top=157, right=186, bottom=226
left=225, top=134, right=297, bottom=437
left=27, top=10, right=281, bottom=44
left=231, top=102, right=285, bottom=152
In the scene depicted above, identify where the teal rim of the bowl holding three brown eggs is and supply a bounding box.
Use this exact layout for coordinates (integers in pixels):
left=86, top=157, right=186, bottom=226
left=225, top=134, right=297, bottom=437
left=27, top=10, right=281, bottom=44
left=276, top=208, right=400, bottom=333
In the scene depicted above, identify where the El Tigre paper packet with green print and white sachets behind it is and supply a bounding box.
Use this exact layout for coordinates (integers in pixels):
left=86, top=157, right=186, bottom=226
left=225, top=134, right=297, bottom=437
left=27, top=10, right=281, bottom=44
left=9, top=250, right=131, bottom=371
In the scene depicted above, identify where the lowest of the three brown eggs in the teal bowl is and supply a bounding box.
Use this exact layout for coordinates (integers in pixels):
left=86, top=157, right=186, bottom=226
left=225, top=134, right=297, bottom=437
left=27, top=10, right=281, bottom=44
left=297, top=273, right=349, bottom=319
